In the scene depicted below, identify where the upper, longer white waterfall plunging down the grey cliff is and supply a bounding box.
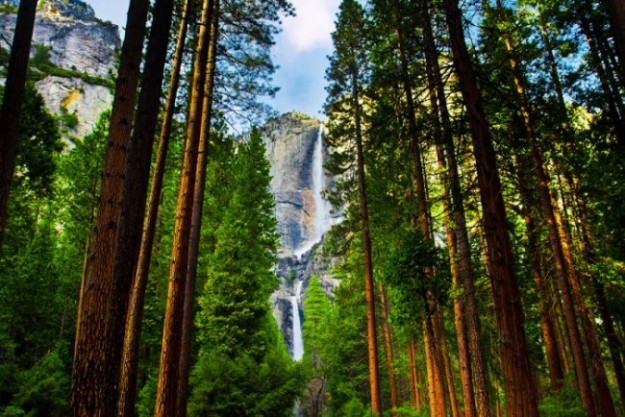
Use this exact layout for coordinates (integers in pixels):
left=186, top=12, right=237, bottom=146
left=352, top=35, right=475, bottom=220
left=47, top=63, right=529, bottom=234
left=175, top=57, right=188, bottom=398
left=293, top=124, right=332, bottom=259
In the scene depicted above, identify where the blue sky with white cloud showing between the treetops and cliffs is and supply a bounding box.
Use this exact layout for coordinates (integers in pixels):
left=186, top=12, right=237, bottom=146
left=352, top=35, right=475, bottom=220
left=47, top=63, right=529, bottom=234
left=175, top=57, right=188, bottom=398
left=87, top=0, right=340, bottom=119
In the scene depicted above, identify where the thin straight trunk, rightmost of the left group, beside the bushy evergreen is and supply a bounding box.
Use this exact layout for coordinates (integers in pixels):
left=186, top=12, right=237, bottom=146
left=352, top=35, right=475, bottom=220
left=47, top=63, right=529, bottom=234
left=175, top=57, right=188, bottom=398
left=176, top=0, right=219, bottom=417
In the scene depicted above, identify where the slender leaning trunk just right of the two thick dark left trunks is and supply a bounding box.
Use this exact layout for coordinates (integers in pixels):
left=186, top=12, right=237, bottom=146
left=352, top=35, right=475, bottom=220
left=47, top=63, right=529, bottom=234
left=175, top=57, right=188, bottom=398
left=118, top=0, right=191, bottom=417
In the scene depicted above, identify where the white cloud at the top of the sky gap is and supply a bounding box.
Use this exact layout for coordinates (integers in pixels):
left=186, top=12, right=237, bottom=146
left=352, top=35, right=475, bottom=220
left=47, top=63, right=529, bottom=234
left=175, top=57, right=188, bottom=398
left=282, top=0, right=339, bottom=52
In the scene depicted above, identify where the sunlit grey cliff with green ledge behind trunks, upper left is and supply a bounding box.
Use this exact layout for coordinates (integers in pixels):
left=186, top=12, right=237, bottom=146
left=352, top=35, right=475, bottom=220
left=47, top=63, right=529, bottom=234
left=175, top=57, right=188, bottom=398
left=0, top=0, right=120, bottom=137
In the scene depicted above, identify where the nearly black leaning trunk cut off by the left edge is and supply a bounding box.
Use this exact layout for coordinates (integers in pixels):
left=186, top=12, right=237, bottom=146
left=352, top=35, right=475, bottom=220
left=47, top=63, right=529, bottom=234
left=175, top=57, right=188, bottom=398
left=0, top=0, right=37, bottom=257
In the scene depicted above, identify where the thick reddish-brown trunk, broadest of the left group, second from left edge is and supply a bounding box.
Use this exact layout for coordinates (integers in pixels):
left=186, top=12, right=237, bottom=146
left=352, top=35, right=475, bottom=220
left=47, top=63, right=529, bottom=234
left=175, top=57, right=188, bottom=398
left=70, top=0, right=150, bottom=417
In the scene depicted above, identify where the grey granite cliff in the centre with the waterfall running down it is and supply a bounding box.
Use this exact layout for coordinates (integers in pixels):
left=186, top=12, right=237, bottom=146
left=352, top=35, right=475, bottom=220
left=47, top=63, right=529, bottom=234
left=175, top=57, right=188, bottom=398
left=261, top=113, right=341, bottom=352
